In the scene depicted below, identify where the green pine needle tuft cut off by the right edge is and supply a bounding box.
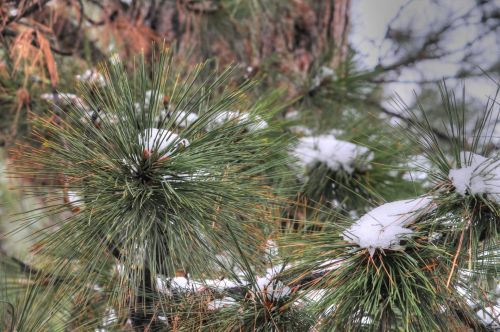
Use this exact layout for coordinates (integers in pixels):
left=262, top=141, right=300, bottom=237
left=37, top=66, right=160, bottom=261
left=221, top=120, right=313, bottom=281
left=400, top=84, right=500, bottom=272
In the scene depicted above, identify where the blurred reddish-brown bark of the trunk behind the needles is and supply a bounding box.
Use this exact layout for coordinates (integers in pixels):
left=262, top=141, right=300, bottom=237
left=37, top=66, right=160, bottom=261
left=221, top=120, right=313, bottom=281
left=143, top=0, right=351, bottom=76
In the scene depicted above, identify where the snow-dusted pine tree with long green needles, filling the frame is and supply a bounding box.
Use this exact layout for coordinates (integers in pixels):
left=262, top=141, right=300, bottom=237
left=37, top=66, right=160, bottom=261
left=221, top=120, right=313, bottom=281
left=0, top=0, right=500, bottom=331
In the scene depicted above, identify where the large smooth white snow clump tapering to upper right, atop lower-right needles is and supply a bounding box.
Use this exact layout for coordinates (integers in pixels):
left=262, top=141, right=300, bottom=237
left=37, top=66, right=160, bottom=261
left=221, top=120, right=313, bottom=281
left=342, top=197, right=431, bottom=256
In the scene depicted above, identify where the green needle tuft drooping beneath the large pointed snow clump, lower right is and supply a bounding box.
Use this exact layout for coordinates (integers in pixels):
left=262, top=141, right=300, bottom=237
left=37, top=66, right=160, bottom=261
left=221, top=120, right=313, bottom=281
left=281, top=206, right=477, bottom=331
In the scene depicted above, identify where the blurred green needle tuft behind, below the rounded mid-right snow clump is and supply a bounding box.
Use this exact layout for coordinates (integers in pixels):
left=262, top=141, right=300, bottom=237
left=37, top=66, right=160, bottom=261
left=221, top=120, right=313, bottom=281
left=301, top=115, right=423, bottom=213
